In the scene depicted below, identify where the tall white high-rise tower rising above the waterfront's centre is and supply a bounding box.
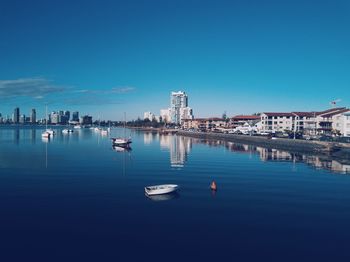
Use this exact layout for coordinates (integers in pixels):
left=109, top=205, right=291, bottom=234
left=170, top=91, right=193, bottom=125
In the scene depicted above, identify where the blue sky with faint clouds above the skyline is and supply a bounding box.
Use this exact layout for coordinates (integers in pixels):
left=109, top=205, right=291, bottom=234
left=0, top=0, right=350, bottom=119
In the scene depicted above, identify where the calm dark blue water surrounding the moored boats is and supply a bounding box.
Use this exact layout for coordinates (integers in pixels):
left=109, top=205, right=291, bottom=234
left=0, top=127, right=350, bottom=261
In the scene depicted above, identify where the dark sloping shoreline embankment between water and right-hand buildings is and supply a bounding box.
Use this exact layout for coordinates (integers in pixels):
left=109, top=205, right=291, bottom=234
left=129, top=127, right=350, bottom=163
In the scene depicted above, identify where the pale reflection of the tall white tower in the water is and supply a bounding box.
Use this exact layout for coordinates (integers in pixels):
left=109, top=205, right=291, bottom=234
left=159, top=135, right=192, bottom=167
